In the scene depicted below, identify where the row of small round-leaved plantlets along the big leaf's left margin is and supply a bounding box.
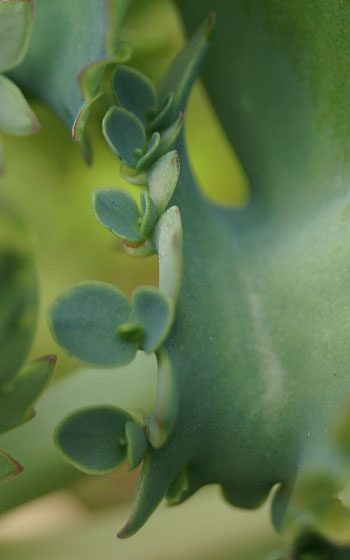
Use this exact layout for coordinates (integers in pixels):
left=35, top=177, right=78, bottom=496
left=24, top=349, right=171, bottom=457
left=49, top=10, right=211, bottom=532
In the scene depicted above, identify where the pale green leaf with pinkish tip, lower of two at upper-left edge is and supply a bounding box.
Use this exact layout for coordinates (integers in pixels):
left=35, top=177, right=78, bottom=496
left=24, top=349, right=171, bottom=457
left=0, top=74, right=40, bottom=136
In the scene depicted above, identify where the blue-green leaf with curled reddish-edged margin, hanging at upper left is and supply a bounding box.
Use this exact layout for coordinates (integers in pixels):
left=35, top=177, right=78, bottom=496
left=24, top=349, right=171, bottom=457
left=12, top=0, right=129, bottom=138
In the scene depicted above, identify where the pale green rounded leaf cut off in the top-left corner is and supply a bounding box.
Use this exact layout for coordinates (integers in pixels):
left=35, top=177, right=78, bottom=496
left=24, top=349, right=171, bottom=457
left=0, top=0, right=33, bottom=72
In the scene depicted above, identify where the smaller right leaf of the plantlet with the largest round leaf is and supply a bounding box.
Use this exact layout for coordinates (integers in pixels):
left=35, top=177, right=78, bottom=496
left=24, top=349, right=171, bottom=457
left=132, top=286, right=174, bottom=354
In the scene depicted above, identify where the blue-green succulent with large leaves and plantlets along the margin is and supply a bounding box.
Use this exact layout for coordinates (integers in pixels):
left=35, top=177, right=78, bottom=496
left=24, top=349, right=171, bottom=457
left=0, top=0, right=350, bottom=558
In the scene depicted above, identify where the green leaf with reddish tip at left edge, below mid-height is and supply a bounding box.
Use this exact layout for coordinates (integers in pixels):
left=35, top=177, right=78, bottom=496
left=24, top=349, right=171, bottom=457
left=0, top=356, right=56, bottom=433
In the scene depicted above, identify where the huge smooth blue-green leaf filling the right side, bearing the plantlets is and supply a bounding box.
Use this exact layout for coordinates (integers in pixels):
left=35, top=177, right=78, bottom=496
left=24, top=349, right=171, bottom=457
left=117, top=0, right=350, bottom=546
